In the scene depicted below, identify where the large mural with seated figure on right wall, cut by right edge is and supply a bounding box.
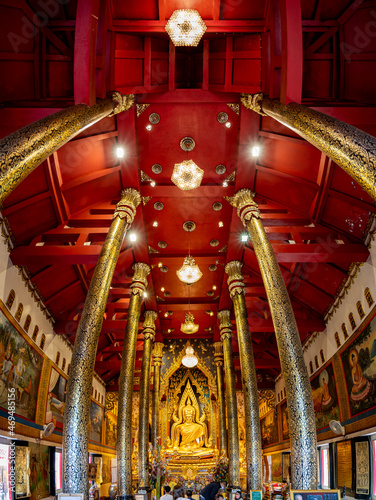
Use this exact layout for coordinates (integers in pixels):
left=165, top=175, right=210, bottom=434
left=341, top=318, right=376, bottom=416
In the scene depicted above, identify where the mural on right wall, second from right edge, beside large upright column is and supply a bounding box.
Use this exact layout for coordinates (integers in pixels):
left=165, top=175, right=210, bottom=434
left=311, top=363, right=341, bottom=429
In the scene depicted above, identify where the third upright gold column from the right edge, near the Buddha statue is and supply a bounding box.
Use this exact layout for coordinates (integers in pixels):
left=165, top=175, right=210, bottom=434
left=218, top=310, right=240, bottom=490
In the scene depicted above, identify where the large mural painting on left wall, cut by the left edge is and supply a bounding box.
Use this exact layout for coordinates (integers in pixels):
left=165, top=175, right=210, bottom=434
left=0, top=310, right=43, bottom=420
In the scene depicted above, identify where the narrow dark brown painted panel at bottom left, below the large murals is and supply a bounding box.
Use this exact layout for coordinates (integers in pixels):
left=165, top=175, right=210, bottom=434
left=29, top=443, right=50, bottom=500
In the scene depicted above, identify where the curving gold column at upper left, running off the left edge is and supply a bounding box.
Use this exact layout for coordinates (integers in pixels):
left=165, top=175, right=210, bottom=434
left=0, top=92, right=134, bottom=209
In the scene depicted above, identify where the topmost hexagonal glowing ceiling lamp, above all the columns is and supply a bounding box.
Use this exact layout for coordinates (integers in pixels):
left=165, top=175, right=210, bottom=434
left=165, top=9, right=206, bottom=47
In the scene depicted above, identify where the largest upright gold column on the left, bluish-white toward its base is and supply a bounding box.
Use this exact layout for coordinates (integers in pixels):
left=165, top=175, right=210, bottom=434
left=63, top=189, right=141, bottom=498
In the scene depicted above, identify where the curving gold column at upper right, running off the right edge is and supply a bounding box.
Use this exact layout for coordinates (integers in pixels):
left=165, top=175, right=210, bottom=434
left=241, top=94, right=376, bottom=200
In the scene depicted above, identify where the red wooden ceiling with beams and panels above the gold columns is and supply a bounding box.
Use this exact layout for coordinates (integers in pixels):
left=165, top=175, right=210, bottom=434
left=0, top=0, right=376, bottom=388
